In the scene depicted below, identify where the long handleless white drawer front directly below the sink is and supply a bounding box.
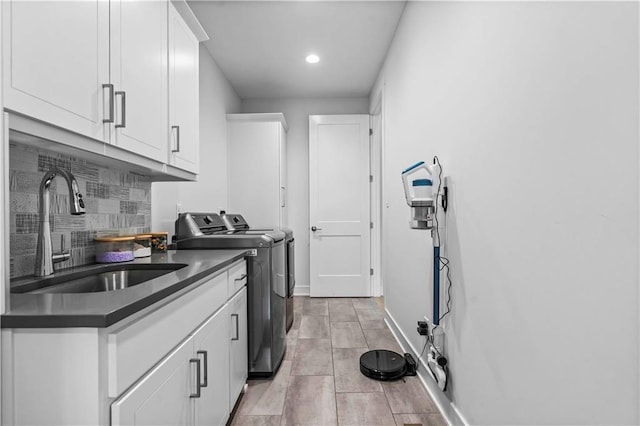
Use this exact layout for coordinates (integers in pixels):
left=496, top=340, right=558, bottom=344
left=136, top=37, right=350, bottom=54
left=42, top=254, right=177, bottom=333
left=107, top=271, right=228, bottom=397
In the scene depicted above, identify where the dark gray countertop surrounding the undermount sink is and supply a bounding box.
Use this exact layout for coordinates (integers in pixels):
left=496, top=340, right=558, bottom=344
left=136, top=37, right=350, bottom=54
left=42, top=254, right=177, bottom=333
left=1, top=250, right=247, bottom=328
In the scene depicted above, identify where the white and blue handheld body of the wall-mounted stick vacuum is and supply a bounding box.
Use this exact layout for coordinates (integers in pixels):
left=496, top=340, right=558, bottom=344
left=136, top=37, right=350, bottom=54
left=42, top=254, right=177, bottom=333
left=402, top=161, right=434, bottom=229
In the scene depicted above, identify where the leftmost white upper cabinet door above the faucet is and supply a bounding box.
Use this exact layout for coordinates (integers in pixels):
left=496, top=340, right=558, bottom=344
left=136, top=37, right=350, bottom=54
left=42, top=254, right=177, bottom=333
left=1, top=1, right=109, bottom=140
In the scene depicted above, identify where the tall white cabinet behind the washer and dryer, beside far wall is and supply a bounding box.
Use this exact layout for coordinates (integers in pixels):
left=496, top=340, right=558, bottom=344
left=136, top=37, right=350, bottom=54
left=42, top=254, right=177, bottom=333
left=227, top=113, right=287, bottom=227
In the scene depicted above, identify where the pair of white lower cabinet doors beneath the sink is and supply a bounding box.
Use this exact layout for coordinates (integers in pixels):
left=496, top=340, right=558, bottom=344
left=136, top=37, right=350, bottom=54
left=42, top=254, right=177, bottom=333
left=111, top=304, right=232, bottom=426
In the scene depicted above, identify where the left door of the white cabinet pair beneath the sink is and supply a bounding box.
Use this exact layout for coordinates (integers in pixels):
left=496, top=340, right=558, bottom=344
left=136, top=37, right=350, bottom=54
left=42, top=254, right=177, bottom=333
left=111, top=338, right=198, bottom=426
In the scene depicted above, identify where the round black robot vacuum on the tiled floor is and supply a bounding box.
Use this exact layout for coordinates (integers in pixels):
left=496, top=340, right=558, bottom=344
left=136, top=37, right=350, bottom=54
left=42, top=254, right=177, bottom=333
left=360, top=349, right=417, bottom=381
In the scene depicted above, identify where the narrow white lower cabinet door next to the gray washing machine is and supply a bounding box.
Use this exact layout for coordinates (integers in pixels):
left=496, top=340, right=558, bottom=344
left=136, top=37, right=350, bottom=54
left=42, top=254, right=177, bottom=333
left=229, top=287, right=249, bottom=410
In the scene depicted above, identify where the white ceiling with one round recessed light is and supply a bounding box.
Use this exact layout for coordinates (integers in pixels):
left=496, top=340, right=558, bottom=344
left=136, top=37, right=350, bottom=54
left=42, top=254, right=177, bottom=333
left=188, top=0, right=405, bottom=99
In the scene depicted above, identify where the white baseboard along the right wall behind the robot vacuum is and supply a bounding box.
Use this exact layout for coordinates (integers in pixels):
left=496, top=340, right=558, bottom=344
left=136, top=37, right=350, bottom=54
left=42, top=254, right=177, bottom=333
left=384, top=309, right=469, bottom=426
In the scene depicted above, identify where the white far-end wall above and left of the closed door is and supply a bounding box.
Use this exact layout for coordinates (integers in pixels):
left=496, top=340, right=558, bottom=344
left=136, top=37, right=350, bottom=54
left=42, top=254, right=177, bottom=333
left=240, top=98, right=369, bottom=294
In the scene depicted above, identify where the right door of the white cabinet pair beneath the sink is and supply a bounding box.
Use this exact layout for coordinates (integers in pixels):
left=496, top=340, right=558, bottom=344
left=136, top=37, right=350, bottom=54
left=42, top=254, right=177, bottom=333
left=193, top=304, right=230, bottom=425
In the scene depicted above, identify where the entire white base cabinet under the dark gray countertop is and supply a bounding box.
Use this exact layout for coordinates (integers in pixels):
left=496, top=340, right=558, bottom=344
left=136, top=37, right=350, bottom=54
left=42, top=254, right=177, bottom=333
left=0, top=260, right=248, bottom=426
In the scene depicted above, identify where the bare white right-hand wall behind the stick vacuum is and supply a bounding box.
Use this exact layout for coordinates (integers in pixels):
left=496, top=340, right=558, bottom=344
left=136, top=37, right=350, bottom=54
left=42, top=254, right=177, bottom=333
left=372, top=2, right=640, bottom=424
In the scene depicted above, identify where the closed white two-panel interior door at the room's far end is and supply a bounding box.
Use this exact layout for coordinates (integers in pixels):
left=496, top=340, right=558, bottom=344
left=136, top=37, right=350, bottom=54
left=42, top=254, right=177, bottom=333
left=309, top=115, right=371, bottom=297
